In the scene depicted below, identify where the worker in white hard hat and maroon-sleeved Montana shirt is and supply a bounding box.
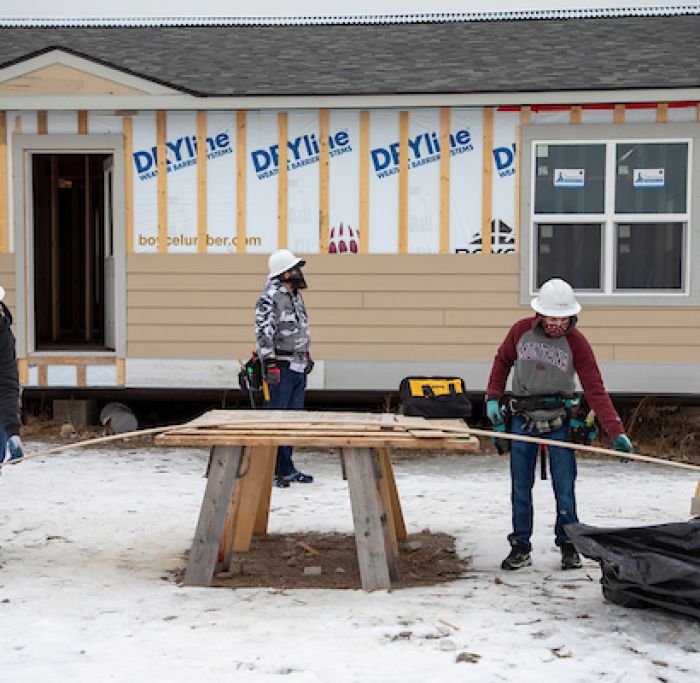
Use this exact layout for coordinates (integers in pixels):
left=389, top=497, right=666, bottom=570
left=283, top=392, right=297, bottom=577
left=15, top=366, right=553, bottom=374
left=486, top=279, right=632, bottom=569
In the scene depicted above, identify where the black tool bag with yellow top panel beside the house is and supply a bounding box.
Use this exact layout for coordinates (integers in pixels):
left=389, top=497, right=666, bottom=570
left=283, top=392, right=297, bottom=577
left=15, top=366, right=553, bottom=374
left=399, top=377, right=472, bottom=418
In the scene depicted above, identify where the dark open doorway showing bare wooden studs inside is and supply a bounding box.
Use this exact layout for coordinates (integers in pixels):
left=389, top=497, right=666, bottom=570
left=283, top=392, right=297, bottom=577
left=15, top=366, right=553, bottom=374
left=32, top=153, right=114, bottom=351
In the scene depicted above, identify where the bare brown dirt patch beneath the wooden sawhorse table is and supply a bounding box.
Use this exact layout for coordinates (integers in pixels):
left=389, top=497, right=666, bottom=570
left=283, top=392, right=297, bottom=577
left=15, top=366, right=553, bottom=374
left=175, top=530, right=469, bottom=589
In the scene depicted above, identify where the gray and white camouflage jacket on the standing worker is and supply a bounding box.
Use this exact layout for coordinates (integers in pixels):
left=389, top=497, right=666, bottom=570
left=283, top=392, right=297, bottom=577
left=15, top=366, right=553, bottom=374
left=255, top=279, right=311, bottom=372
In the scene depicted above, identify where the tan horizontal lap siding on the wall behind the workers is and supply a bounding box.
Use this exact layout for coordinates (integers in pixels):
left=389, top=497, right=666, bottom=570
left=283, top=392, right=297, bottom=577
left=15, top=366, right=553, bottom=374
left=127, top=254, right=700, bottom=362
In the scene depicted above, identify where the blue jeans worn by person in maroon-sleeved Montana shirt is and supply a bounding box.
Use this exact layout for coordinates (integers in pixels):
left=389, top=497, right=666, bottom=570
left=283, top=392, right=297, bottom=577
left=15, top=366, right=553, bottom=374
left=508, top=417, right=578, bottom=550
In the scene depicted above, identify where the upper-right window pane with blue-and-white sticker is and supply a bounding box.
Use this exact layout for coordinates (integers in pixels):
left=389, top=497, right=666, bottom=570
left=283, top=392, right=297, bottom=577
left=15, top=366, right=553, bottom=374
left=615, top=142, right=688, bottom=213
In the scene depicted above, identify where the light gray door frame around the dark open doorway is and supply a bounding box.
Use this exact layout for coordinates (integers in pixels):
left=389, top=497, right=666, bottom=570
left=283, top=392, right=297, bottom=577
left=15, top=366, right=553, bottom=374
left=13, top=134, right=126, bottom=358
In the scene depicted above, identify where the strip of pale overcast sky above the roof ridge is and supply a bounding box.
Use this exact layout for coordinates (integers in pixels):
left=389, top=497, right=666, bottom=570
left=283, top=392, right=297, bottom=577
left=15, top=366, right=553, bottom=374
left=0, top=0, right=700, bottom=18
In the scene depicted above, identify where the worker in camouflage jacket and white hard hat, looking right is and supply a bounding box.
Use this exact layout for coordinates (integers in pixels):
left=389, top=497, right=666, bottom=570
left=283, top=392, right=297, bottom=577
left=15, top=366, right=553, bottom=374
left=255, top=249, right=314, bottom=487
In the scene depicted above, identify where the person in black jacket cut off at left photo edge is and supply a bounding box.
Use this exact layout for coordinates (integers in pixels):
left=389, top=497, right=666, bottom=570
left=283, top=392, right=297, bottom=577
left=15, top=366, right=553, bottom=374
left=0, top=287, right=24, bottom=468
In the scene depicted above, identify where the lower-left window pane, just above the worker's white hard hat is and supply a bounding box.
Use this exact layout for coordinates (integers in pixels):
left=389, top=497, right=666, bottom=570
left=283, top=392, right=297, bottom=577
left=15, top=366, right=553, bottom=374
left=536, top=223, right=602, bottom=290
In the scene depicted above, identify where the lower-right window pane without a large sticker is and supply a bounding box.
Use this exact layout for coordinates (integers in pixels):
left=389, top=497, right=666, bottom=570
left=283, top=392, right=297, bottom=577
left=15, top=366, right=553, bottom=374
left=616, top=223, right=684, bottom=289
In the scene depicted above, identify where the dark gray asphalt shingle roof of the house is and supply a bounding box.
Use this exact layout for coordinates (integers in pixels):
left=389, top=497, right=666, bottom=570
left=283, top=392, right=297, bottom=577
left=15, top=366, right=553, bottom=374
left=0, top=15, right=700, bottom=96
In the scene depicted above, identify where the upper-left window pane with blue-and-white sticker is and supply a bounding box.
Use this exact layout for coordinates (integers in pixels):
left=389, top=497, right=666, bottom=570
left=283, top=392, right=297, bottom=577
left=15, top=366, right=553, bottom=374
left=535, top=143, right=605, bottom=213
